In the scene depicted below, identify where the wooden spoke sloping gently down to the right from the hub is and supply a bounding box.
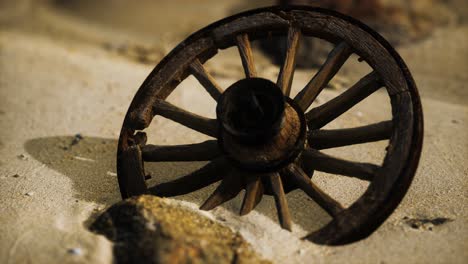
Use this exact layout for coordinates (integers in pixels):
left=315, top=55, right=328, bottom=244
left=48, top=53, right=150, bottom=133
left=302, top=149, right=380, bottom=181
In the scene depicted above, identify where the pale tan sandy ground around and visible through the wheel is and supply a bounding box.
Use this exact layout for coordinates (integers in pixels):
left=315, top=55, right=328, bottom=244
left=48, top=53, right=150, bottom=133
left=0, top=1, right=468, bottom=263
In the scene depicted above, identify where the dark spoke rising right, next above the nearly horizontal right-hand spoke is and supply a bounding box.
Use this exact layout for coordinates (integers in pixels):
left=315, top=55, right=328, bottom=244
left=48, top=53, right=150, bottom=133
left=306, top=72, right=383, bottom=129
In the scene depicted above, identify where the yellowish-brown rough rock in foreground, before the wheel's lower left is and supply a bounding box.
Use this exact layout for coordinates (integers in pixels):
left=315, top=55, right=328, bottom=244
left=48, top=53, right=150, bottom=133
left=90, top=195, right=268, bottom=263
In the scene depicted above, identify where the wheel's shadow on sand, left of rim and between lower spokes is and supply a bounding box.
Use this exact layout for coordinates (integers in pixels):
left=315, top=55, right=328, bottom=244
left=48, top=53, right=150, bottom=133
left=25, top=136, right=330, bottom=231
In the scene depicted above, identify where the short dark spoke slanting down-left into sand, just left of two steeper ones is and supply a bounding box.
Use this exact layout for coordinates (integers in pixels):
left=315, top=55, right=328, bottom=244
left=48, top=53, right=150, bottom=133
left=200, top=169, right=243, bottom=211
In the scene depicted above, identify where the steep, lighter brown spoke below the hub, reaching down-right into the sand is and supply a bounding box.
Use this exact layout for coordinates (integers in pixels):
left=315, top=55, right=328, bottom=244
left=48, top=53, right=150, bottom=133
left=268, top=173, right=292, bottom=231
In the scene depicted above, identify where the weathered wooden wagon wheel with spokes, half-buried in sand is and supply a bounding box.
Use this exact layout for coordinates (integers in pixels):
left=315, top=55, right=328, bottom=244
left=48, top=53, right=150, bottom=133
left=117, top=7, right=423, bottom=244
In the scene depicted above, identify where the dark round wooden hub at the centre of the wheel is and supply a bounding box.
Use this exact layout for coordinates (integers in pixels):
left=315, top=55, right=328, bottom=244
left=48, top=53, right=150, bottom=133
left=216, top=78, right=306, bottom=172
